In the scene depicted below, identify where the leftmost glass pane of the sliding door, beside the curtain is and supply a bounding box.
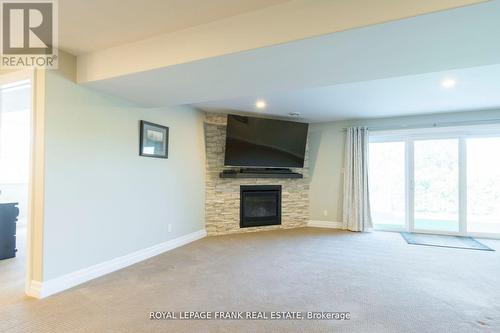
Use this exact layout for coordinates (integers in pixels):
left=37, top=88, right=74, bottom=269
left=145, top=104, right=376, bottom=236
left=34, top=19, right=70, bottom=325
left=369, top=142, right=406, bottom=229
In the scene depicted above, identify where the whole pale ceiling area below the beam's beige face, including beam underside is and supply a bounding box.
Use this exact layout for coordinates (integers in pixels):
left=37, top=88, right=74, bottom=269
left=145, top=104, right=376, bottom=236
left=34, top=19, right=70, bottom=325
left=85, top=1, right=500, bottom=121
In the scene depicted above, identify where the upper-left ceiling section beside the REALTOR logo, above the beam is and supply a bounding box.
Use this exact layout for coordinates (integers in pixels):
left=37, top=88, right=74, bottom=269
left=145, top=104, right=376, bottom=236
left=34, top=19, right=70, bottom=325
left=59, top=0, right=289, bottom=55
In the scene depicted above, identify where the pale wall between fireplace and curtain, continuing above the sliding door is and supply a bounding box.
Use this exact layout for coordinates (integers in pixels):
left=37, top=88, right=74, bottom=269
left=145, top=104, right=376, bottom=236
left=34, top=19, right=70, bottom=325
left=309, top=111, right=500, bottom=222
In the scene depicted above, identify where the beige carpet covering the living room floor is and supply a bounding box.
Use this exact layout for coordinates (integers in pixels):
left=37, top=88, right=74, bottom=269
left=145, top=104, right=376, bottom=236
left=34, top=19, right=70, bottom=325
left=0, top=228, right=500, bottom=333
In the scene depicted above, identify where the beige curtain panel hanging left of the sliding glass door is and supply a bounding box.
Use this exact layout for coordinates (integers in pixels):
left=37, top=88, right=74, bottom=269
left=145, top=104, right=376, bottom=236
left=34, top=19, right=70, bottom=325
left=343, top=127, right=372, bottom=231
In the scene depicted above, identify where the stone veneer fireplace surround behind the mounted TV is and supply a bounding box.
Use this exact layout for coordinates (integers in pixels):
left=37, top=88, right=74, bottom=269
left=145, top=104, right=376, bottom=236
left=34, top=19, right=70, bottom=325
left=205, top=113, right=309, bottom=235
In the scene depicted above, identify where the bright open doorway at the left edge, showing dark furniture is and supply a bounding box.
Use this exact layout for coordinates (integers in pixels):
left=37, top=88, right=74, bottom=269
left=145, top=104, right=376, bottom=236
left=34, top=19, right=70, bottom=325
left=0, top=75, right=32, bottom=305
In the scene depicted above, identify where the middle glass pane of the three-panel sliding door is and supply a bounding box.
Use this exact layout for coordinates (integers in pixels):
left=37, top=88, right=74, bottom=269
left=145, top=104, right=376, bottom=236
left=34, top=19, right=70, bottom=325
left=414, top=139, right=459, bottom=231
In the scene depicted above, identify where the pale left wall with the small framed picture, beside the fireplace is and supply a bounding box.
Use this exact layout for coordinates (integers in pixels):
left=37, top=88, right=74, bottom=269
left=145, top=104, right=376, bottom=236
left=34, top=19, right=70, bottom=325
left=43, top=71, right=205, bottom=281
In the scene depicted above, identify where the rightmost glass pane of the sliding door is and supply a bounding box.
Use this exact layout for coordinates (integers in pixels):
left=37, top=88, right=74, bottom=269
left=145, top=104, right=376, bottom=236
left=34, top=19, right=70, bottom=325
left=467, top=138, right=500, bottom=233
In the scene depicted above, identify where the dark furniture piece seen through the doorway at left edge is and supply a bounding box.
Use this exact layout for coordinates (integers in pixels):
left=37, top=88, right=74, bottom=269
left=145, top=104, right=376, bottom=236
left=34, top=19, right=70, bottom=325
left=0, top=202, right=19, bottom=260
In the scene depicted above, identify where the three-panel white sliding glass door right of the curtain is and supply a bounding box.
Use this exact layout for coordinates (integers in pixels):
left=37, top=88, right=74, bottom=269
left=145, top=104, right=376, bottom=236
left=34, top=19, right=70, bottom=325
left=369, top=128, right=500, bottom=238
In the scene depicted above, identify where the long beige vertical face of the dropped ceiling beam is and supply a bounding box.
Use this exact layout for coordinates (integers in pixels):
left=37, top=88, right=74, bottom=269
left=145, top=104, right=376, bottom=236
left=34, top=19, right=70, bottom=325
left=78, top=0, right=484, bottom=84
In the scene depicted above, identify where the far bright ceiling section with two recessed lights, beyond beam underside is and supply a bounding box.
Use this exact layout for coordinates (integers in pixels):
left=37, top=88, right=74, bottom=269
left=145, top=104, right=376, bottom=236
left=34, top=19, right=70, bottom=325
left=195, top=65, right=500, bottom=122
